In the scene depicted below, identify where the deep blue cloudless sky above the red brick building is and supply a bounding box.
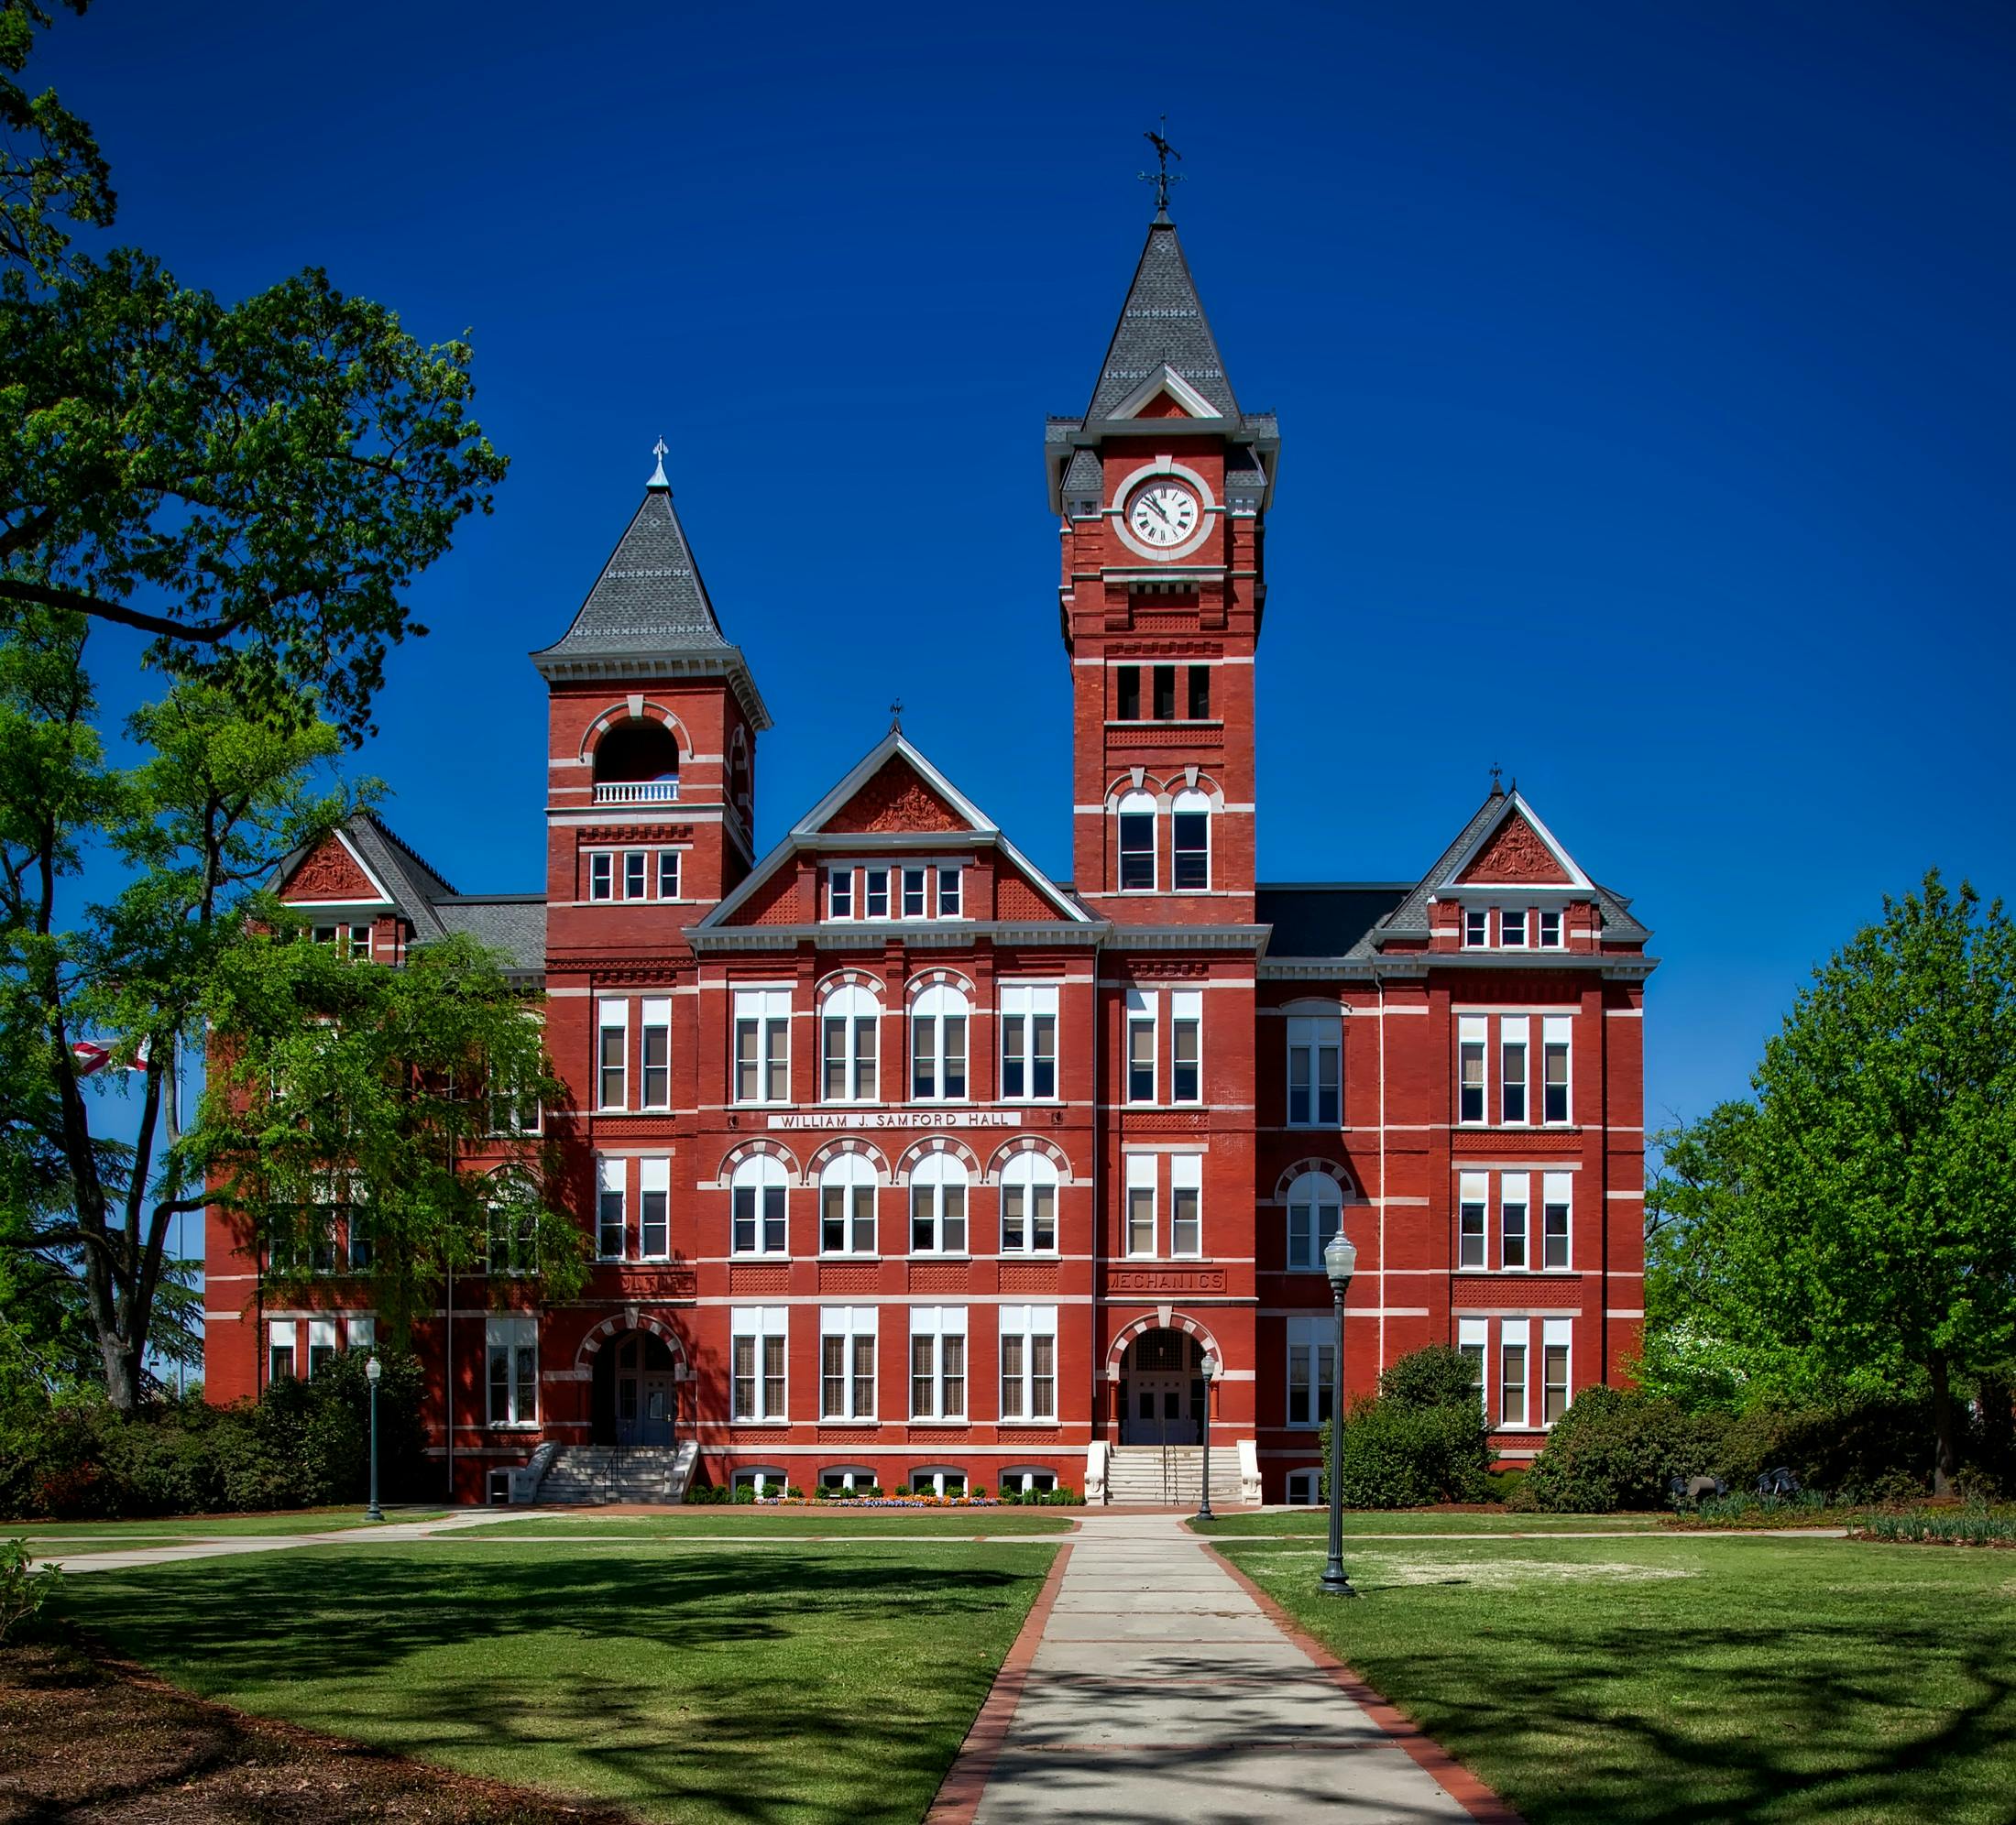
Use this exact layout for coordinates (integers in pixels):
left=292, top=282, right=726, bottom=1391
left=30, top=0, right=2016, bottom=1123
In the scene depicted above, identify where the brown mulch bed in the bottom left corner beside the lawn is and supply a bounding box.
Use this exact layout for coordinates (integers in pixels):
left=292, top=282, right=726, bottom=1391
left=0, top=1644, right=629, bottom=1825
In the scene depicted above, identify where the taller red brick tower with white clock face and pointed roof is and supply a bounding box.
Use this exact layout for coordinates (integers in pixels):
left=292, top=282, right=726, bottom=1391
left=1045, top=208, right=1280, bottom=928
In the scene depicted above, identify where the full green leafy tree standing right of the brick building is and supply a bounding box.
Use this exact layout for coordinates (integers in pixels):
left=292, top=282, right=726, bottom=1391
left=1660, top=871, right=2016, bottom=1492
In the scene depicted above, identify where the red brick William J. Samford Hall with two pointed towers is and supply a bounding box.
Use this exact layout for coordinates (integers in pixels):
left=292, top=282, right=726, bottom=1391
left=208, top=220, right=1653, bottom=1501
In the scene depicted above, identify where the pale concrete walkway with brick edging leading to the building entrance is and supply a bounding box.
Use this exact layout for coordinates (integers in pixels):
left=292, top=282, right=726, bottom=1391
left=955, top=1513, right=1510, bottom=1825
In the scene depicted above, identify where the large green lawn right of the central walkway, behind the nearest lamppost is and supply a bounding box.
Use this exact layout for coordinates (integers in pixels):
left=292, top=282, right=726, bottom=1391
left=1220, top=1533, right=2016, bottom=1825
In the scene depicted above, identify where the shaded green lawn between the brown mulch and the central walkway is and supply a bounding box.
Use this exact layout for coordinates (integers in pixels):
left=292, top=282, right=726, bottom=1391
left=57, top=1541, right=1055, bottom=1825
